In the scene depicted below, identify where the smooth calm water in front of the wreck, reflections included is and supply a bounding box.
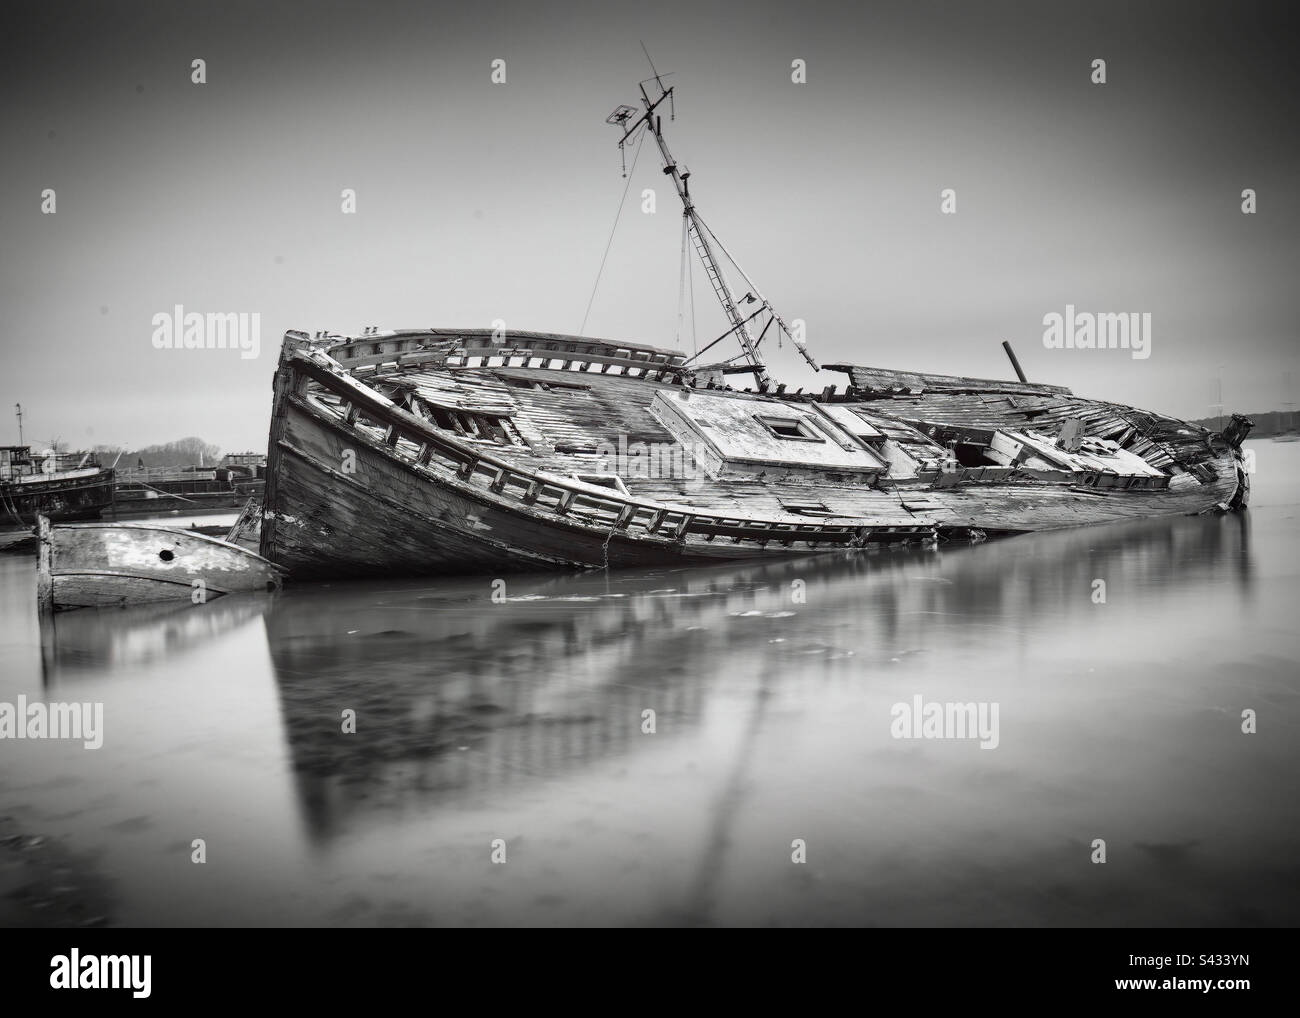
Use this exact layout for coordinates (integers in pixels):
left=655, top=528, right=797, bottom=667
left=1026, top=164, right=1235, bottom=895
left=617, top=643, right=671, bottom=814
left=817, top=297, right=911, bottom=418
left=0, top=441, right=1300, bottom=926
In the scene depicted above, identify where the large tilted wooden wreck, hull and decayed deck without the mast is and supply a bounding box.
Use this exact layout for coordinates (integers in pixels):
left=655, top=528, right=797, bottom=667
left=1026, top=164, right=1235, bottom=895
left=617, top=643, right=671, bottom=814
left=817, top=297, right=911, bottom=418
left=261, top=330, right=1248, bottom=579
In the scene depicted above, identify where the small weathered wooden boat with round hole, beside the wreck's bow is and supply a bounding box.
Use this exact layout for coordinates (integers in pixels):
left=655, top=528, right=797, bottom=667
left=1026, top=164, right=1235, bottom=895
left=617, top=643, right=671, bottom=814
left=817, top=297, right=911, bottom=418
left=36, top=517, right=281, bottom=612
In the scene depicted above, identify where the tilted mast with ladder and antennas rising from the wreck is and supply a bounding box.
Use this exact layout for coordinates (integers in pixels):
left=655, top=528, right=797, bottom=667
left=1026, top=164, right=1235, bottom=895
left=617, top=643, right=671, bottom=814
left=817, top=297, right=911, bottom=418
left=606, top=67, right=818, bottom=391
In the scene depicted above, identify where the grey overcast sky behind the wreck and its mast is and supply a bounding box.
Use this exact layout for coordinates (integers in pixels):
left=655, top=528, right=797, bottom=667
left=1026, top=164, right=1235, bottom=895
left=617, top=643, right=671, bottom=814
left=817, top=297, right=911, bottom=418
left=0, top=0, right=1300, bottom=451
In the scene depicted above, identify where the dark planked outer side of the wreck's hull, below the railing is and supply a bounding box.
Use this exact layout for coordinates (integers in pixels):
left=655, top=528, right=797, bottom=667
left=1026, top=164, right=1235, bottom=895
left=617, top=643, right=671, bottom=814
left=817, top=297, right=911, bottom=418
left=261, top=387, right=931, bottom=579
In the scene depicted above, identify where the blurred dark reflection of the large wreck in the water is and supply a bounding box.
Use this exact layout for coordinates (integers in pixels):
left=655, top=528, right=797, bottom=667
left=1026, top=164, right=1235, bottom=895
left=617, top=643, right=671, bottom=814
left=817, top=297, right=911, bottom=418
left=256, top=516, right=1249, bottom=847
